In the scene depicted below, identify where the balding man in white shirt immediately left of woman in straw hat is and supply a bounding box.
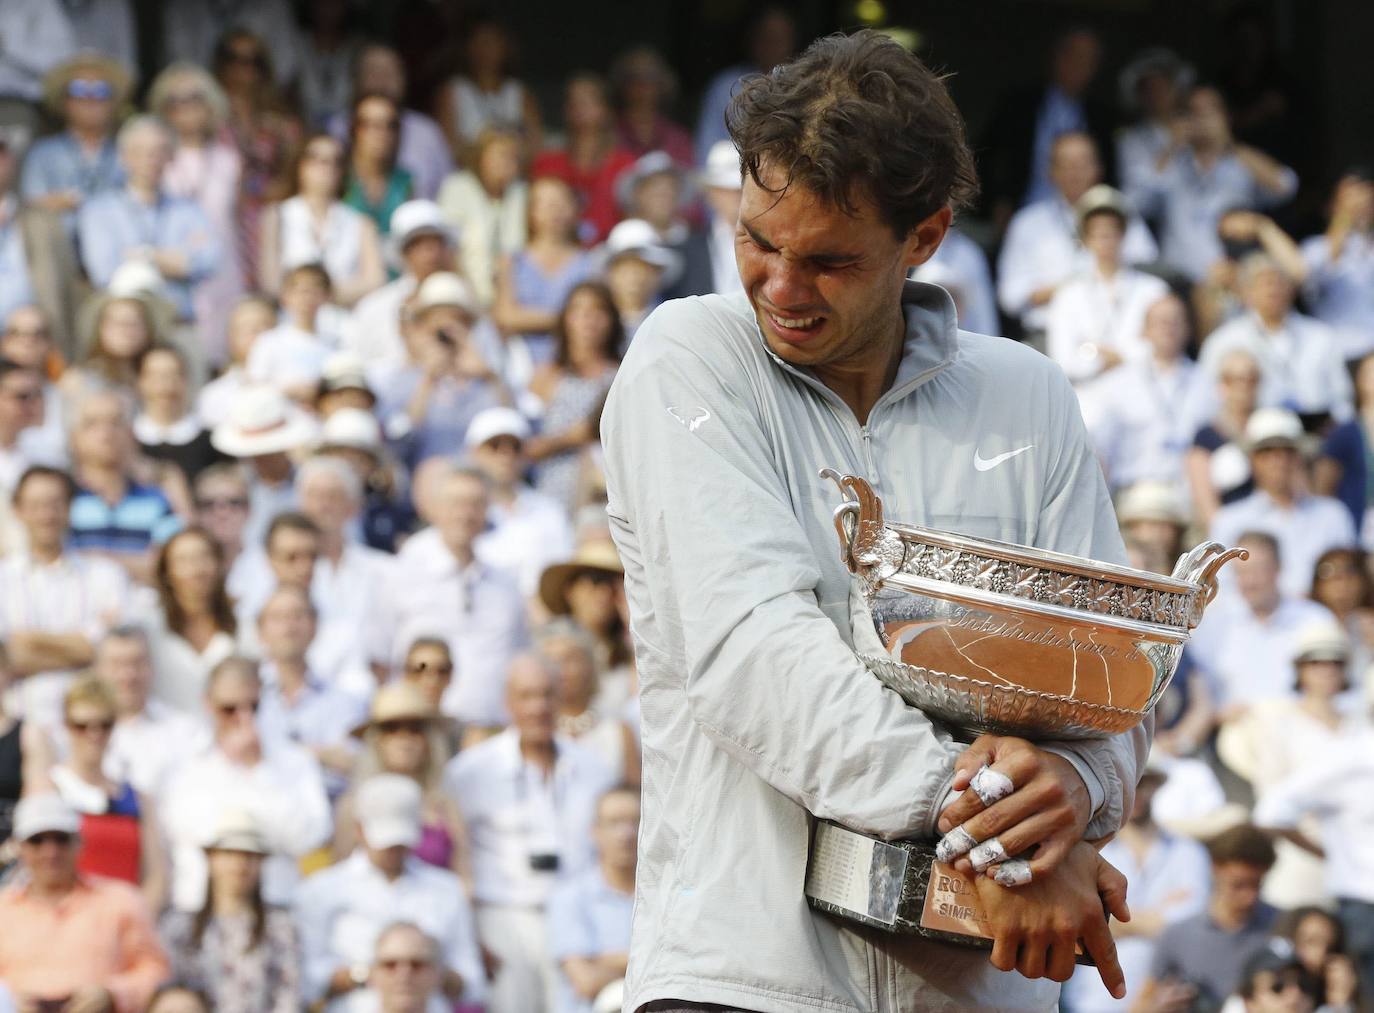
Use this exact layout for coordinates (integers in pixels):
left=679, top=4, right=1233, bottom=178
left=372, top=466, right=526, bottom=730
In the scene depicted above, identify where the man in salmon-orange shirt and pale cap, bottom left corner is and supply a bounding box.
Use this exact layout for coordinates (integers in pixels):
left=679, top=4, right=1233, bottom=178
left=0, top=794, right=168, bottom=1013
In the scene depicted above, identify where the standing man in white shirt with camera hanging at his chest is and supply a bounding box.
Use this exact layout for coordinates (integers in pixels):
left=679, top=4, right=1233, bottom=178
left=447, top=654, right=613, bottom=1013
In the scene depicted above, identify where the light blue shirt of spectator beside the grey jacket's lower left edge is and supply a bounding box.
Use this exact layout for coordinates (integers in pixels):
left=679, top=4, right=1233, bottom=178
left=548, top=867, right=635, bottom=1013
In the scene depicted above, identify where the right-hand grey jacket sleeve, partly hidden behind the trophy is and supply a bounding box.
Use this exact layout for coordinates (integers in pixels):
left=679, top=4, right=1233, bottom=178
left=1035, top=362, right=1154, bottom=840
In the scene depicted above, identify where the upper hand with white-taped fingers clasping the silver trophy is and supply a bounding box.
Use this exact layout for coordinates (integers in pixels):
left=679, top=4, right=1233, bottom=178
left=938, top=735, right=1092, bottom=880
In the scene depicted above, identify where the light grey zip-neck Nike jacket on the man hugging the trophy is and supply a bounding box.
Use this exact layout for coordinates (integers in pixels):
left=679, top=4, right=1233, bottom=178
left=602, top=282, right=1151, bottom=1013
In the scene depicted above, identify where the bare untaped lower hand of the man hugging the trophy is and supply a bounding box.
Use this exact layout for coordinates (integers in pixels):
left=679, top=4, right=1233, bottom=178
left=976, top=841, right=1131, bottom=999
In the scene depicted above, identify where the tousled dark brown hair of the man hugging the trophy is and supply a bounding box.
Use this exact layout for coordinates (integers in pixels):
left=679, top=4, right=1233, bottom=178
left=725, top=29, right=978, bottom=239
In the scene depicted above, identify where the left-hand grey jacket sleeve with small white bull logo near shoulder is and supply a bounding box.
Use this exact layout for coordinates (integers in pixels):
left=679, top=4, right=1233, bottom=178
left=602, top=312, right=960, bottom=838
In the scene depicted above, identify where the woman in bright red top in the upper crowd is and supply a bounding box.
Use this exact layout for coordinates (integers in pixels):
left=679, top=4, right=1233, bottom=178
left=530, top=73, right=635, bottom=243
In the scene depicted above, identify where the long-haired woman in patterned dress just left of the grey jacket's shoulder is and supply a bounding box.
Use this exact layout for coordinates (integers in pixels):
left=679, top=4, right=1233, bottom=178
left=525, top=282, right=624, bottom=509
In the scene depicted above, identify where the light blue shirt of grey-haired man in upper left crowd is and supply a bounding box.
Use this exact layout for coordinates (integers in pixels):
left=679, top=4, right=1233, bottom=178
left=77, top=190, right=221, bottom=320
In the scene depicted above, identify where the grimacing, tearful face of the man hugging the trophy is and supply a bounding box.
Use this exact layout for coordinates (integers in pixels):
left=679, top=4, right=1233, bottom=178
left=735, top=165, right=943, bottom=370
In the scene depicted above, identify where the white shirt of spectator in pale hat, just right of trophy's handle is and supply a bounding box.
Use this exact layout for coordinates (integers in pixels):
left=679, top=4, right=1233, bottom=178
left=1210, top=489, right=1356, bottom=598
